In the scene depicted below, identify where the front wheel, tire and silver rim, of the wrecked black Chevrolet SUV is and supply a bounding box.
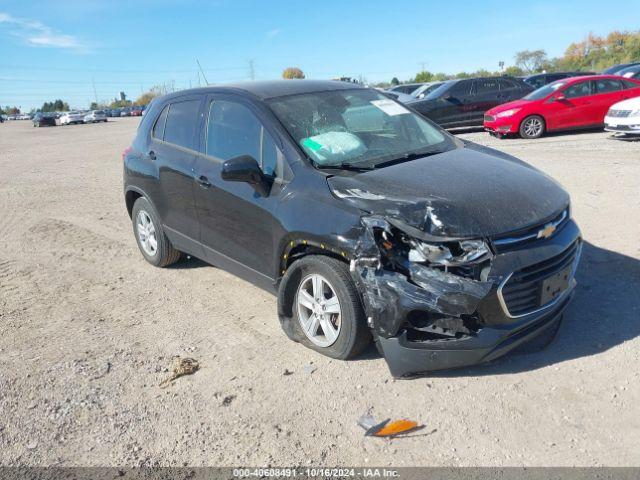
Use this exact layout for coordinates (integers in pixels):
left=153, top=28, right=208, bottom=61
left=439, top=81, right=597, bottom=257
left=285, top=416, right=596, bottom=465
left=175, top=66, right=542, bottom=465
left=292, top=255, right=371, bottom=360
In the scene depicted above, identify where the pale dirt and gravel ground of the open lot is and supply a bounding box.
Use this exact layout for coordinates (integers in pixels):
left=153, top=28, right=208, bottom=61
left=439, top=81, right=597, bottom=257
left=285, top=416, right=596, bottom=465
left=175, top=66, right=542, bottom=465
left=0, top=118, right=640, bottom=466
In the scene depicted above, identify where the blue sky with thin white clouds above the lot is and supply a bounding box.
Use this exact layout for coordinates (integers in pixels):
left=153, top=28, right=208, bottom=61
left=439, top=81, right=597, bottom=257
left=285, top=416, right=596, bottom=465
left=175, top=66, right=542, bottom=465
left=0, top=0, right=640, bottom=111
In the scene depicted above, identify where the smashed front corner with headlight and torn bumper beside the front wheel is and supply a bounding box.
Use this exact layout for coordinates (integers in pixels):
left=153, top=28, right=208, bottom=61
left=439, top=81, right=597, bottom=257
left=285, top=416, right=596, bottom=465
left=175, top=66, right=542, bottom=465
left=351, top=216, right=492, bottom=340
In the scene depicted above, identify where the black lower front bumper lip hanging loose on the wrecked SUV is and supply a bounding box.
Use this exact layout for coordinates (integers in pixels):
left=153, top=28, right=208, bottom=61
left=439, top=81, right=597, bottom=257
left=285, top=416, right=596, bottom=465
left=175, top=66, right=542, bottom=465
left=378, top=290, right=575, bottom=377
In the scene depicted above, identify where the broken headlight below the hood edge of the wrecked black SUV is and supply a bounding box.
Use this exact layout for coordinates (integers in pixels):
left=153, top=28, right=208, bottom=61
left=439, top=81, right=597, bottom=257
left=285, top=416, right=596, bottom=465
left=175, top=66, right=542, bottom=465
left=407, top=238, right=491, bottom=267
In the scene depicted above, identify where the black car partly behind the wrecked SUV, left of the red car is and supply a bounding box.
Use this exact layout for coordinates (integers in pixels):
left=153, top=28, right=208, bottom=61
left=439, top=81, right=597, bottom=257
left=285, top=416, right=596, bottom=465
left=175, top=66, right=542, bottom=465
left=405, top=77, right=534, bottom=128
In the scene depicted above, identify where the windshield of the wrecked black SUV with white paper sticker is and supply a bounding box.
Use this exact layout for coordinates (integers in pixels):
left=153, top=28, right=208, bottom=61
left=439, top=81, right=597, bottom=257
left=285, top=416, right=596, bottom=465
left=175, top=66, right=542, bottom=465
left=269, top=89, right=455, bottom=168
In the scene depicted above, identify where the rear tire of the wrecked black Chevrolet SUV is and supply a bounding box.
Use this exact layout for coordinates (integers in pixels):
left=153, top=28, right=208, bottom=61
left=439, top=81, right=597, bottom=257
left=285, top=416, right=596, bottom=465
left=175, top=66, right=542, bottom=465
left=131, top=197, right=182, bottom=267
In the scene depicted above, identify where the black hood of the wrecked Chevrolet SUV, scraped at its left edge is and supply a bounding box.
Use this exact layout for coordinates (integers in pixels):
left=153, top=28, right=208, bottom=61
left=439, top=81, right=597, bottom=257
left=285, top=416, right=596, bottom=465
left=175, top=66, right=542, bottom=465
left=327, top=143, right=569, bottom=239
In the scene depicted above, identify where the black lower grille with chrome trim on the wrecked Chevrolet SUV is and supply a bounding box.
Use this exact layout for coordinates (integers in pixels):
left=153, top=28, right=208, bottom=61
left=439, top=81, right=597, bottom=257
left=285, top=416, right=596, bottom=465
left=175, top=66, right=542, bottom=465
left=500, top=240, right=580, bottom=317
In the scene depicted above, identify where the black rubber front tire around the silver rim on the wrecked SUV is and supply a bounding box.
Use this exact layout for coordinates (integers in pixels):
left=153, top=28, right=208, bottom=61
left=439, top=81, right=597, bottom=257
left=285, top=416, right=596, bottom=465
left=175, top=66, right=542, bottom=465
left=291, top=255, right=371, bottom=360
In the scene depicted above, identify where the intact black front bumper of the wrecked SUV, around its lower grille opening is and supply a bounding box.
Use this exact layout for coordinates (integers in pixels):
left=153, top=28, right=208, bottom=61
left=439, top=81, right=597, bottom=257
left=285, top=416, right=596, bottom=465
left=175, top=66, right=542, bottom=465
left=377, top=220, right=581, bottom=377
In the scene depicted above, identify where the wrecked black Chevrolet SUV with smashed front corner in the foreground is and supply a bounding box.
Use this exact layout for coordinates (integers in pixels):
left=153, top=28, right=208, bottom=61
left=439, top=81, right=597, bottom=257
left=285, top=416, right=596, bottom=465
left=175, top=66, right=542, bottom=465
left=123, top=80, right=581, bottom=376
